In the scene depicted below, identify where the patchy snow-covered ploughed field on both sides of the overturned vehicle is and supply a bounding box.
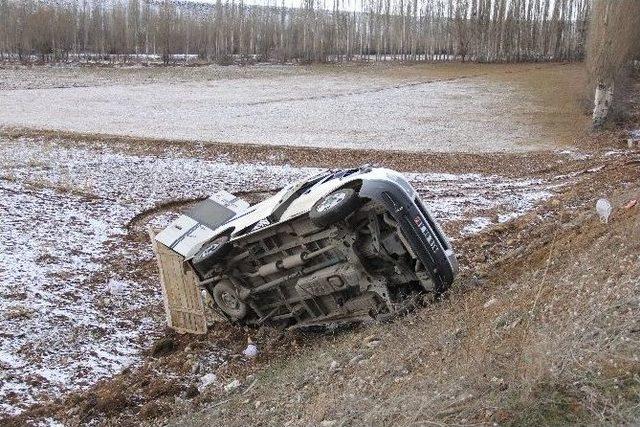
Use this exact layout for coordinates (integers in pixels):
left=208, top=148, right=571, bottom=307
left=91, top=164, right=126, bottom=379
left=0, top=139, right=558, bottom=414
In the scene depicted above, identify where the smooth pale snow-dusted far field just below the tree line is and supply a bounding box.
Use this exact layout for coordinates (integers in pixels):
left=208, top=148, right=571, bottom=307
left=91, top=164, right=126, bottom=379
left=0, top=64, right=586, bottom=152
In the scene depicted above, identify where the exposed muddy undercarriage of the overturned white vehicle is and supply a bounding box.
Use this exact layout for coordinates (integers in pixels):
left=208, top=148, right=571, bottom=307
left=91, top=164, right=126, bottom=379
left=200, top=197, right=434, bottom=326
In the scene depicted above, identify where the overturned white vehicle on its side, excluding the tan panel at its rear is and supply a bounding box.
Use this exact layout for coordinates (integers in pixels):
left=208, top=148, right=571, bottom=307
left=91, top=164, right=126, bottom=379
left=155, top=166, right=458, bottom=332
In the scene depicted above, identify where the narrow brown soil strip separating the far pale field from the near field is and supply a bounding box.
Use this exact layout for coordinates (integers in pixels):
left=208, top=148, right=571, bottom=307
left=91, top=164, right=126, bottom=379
left=1, top=124, right=627, bottom=177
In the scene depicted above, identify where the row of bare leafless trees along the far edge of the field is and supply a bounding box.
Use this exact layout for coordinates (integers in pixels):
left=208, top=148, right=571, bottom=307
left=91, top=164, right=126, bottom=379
left=0, top=0, right=591, bottom=62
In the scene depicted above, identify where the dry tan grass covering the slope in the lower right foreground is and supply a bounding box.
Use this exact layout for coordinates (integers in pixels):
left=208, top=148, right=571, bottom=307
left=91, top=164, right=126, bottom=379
left=172, top=160, right=640, bottom=426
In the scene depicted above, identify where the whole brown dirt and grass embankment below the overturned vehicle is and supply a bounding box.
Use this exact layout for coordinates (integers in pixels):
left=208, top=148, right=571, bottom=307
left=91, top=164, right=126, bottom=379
left=9, top=145, right=640, bottom=425
